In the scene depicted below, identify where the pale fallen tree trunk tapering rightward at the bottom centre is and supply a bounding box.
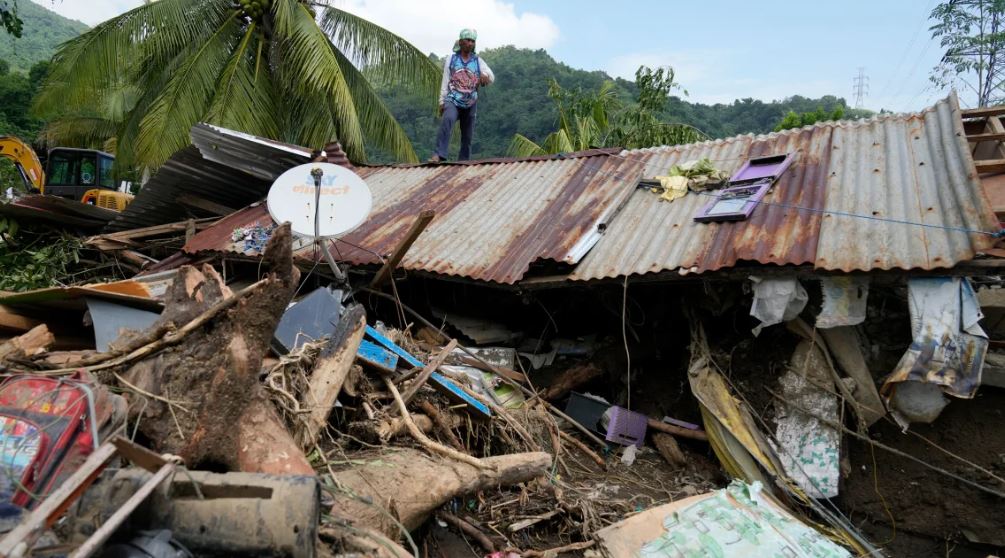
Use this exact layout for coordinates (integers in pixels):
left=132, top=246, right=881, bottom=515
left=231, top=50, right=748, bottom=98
left=332, top=448, right=552, bottom=540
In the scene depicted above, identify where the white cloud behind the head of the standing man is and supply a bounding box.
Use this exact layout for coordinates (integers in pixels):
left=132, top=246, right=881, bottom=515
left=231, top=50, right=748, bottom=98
left=333, top=0, right=560, bottom=55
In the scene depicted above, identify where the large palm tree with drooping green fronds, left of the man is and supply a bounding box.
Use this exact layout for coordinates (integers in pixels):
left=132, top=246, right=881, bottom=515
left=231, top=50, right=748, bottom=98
left=35, top=0, right=438, bottom=167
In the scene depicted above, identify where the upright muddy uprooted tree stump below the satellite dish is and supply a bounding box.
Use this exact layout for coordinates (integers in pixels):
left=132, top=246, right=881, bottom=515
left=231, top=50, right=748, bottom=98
left=122, top=225, right=301, bottom=470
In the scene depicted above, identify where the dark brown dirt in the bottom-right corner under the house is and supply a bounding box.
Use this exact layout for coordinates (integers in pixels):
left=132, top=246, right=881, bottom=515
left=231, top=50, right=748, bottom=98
left=841, top=387, right=1005, bottom=557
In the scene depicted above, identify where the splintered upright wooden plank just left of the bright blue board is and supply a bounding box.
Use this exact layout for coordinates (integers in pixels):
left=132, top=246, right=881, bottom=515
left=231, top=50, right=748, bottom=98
left=300, top=305, right=367, bottom=447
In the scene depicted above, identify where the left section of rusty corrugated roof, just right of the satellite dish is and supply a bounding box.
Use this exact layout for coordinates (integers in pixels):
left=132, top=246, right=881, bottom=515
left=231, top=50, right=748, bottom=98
left=335, top=154, right=641, bottom=284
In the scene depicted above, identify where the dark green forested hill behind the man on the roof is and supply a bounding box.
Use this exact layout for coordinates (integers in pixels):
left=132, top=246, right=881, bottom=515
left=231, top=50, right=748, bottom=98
left=373, top=46, right=868, bottom=160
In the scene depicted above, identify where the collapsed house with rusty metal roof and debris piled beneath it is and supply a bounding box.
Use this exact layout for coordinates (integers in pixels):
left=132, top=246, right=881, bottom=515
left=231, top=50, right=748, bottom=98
left=0, top=91, right=1005, bottom=556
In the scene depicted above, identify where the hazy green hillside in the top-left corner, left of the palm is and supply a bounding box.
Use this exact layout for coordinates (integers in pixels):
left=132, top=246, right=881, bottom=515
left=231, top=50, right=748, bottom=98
left=0, top=0, right=87, bottom=73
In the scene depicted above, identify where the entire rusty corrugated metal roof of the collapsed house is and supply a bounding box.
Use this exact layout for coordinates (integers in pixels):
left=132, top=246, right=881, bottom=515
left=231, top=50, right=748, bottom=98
left=172, top=97, right=999, bottom=285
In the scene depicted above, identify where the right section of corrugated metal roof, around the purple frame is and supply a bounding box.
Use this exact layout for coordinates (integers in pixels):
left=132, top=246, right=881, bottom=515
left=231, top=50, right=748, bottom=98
left=568, top=96, right=999, bottom=281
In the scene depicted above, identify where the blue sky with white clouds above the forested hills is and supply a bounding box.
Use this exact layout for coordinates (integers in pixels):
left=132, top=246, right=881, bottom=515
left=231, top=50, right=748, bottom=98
left=33, top=0, right=952, bottom=112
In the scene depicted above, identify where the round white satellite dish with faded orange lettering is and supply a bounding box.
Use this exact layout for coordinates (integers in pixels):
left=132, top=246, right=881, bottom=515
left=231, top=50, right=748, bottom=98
left=267, top=163, right=373, bottom=238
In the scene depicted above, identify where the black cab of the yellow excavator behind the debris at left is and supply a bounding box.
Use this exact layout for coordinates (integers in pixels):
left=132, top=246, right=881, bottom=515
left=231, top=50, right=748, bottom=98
left=44, top=147, right=116, bottom=201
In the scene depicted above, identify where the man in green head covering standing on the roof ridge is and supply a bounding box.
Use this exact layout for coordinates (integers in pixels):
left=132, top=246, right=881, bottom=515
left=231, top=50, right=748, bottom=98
left=430, top=29, right=495, bottom=163
